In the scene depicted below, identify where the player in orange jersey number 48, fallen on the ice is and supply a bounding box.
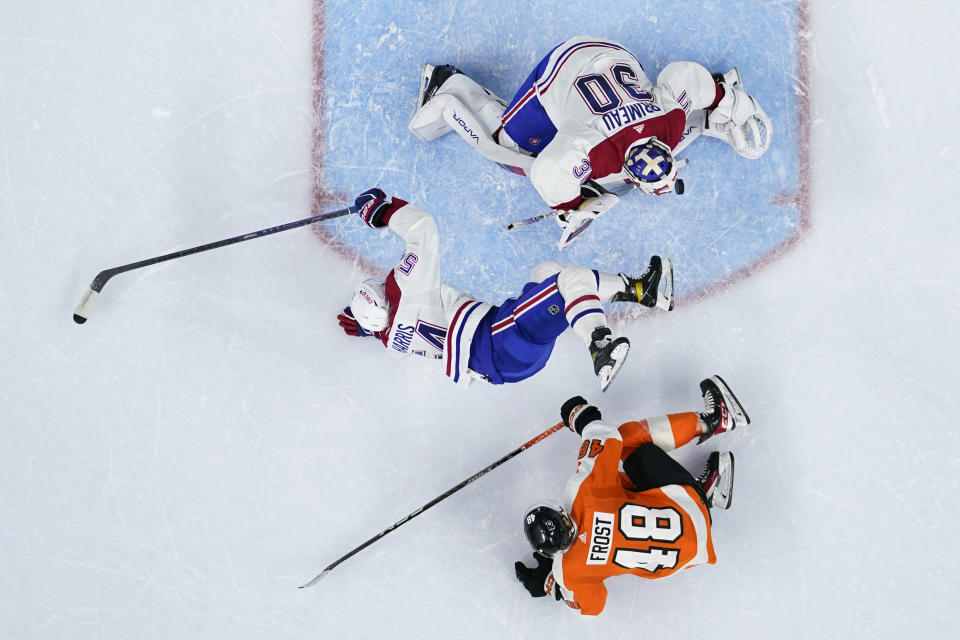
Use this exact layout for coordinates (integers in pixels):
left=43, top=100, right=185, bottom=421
left=514, top=376, right=750, bottom=615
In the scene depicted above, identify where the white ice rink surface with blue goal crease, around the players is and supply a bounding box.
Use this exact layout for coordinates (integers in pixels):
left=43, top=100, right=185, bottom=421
left=0, top=0, right=960, bottom=640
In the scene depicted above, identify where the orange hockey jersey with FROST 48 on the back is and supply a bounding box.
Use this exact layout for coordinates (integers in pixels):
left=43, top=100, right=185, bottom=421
left=547, top=413, right=716, bottom=615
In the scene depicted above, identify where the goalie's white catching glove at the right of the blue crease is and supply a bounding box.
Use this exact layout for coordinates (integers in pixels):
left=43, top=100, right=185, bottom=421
left=704, top=82, right=773, bottom=160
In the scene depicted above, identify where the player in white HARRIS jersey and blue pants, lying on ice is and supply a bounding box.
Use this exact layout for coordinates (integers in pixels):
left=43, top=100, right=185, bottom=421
left=337, top=189, right=673, bottom=390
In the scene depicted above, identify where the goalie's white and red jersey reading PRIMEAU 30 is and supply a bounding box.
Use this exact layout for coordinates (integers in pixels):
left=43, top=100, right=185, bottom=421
left=516, top=37, right=721, bottom=209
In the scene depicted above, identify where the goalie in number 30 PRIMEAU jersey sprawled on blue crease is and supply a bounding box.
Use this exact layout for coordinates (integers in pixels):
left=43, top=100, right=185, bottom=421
left=409, top=37, right=773, bottom=248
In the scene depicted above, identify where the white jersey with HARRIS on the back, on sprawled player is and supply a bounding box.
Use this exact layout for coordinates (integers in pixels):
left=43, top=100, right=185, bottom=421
left=379, top=204, right=491, bottom=386
